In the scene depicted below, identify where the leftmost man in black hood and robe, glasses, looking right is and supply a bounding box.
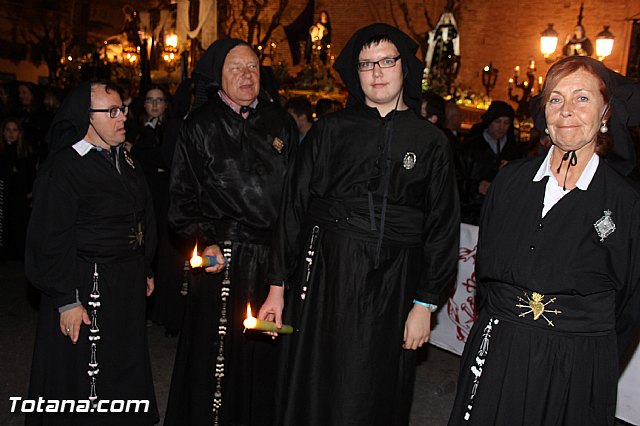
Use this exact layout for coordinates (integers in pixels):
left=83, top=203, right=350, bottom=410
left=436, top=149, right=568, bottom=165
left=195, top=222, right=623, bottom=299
left=25, top=81, right=158, bottom=425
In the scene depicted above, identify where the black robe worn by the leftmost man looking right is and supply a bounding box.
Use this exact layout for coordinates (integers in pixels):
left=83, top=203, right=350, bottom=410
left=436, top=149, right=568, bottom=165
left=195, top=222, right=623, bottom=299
left=25, top=147, right=158, bottom=425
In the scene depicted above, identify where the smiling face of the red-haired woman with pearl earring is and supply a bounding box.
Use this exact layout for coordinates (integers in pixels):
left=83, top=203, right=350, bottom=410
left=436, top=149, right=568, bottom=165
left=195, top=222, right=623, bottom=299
left=545, top=70, right=606, bottom=152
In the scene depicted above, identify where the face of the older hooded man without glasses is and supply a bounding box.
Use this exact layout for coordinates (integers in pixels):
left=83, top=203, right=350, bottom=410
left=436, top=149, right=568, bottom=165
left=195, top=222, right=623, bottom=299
left=222, top=45, right=260, bottom=106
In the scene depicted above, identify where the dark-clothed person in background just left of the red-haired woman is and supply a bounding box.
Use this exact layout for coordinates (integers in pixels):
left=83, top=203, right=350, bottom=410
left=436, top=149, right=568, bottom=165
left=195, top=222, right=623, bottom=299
left=456, top=101, right=522, bottom=225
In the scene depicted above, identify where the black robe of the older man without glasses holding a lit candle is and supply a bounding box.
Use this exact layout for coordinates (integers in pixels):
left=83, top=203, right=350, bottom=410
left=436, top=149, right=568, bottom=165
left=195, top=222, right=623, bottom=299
left=165, top=95, right=298, bottom=426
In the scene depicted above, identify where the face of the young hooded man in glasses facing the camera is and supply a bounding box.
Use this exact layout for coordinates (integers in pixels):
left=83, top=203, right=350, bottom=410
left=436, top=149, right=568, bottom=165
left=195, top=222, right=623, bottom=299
left=358, top=41, right=403, bottom=113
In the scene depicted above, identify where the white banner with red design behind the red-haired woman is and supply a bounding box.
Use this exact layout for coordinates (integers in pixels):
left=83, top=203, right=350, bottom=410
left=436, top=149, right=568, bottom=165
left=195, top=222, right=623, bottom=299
left=429, top=223, right=640, bottom=425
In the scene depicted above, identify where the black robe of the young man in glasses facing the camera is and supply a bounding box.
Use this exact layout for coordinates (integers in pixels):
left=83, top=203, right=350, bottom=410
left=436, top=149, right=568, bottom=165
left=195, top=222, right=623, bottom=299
left=270, top=105, right=459, bottom=426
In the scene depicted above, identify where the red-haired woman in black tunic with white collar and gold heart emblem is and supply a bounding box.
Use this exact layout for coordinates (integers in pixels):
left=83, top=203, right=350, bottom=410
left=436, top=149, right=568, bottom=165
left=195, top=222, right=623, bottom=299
left=449, top=57, right=640, bottom=426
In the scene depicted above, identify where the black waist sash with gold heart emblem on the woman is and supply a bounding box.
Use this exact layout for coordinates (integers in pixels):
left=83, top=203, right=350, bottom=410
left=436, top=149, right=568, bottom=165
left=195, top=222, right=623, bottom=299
left=485, top=282, right=615, bottom=335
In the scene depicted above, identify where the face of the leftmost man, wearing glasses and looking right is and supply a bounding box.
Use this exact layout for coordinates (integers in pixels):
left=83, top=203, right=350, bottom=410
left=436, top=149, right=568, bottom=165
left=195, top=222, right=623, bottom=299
left=86, top=85, right=127, bottom=149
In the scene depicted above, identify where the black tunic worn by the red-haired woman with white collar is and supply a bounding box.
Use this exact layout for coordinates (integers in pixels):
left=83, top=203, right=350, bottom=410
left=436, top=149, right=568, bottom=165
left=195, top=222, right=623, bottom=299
left=449, top=158, right=640, bottom=426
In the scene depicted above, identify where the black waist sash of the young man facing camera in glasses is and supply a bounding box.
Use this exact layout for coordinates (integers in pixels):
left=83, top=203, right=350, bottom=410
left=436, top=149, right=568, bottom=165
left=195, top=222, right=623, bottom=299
left=309, top=198, right=424, bottom=247
